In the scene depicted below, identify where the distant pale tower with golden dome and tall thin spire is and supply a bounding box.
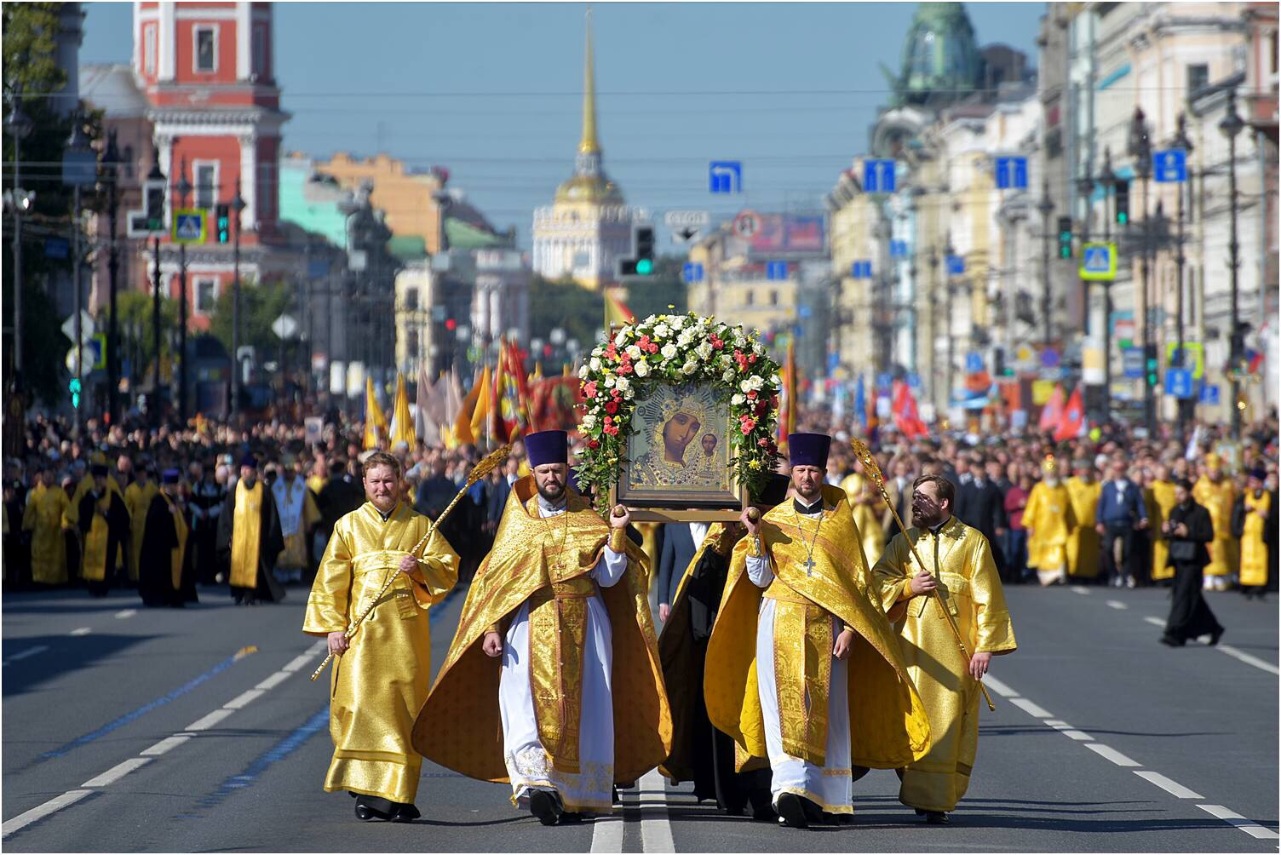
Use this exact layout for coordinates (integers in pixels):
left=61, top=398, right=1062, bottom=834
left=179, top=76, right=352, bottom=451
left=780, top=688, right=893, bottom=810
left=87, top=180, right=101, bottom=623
left=533, top=17, right=644, bottom=291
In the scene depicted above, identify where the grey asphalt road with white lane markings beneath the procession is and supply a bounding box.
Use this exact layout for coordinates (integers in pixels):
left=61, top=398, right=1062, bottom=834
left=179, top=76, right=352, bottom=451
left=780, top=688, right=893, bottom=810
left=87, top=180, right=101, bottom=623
left=0, top=587, right=1278, bottom=852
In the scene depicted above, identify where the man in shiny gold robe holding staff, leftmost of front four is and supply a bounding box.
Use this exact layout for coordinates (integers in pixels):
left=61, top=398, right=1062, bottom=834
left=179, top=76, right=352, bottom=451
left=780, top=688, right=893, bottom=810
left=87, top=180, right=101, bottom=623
left=302, top=451, right=459, bottom=822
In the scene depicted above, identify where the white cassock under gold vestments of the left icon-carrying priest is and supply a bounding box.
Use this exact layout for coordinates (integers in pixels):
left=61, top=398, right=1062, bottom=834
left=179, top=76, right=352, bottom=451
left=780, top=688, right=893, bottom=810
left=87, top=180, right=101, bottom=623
left=498, top=496, right=627, bottom=813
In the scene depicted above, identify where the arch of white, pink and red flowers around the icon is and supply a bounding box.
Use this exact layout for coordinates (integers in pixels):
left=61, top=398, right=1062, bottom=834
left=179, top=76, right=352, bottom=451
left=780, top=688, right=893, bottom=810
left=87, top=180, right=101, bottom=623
left=575, top=313, right=781, bottom=511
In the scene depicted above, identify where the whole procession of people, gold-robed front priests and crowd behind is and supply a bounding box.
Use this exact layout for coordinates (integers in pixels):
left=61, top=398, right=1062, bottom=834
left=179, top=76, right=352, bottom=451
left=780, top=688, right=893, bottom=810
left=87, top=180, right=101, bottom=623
left=4, top=410, right=1278, bottom=827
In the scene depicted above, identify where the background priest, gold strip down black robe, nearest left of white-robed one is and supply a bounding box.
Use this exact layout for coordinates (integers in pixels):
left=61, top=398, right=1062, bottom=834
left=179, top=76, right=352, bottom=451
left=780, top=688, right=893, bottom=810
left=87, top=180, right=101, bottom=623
left=218, top=454, right=284, bottom=605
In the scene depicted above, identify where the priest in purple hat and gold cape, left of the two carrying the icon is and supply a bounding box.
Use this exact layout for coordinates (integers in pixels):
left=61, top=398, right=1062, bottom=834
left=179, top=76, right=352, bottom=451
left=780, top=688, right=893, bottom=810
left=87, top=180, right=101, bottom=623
left=414, top=431, right=671, bottom=826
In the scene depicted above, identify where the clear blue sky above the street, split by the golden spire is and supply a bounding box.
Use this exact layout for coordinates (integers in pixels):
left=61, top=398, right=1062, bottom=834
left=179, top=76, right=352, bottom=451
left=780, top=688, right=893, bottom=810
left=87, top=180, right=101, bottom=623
left=81, top=3, right=1045, bottom=251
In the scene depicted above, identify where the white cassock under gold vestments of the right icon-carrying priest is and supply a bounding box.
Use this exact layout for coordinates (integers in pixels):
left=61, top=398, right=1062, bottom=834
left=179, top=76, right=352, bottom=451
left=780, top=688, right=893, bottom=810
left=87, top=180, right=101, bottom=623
left=747, top=502, right=854, bottom=810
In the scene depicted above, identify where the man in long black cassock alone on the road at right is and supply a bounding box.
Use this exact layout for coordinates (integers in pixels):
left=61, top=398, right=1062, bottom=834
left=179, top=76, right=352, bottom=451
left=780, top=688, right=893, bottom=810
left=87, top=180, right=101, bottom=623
left=1161, top=478, right=1223, bottom=647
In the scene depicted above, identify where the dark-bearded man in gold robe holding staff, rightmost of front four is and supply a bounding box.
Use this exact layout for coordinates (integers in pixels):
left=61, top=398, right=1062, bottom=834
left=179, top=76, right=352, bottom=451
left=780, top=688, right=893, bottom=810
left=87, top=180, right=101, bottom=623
left=872, top=476, right=1017, bottom=824
